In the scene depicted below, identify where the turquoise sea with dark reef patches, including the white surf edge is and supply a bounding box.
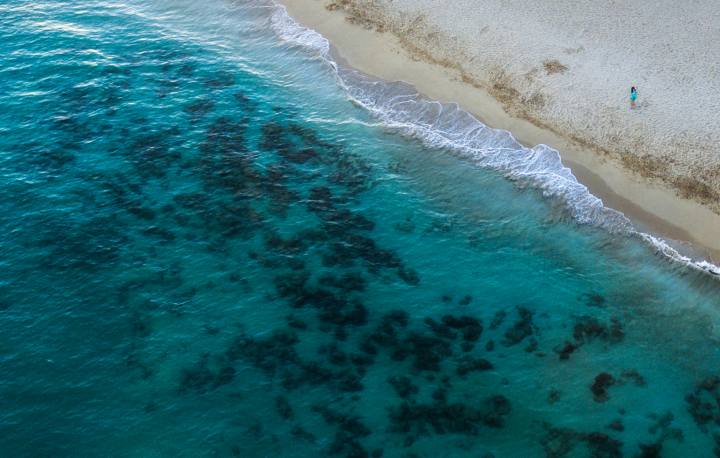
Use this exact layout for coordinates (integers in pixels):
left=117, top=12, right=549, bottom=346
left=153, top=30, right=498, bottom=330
left=0, top=0, right=720, bottom=457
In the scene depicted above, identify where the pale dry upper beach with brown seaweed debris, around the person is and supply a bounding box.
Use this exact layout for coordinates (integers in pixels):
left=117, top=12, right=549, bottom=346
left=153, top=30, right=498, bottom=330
left=328, top=0, right=720, bottom=213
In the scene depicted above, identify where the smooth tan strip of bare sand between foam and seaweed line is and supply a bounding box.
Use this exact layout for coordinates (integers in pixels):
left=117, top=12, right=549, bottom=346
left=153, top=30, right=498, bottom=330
left=280, top=0, right=720, bottom=263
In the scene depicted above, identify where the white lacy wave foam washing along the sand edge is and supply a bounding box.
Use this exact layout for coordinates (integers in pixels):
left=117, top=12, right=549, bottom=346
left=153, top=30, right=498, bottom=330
left=270, top=5, right=720, bottom=276
